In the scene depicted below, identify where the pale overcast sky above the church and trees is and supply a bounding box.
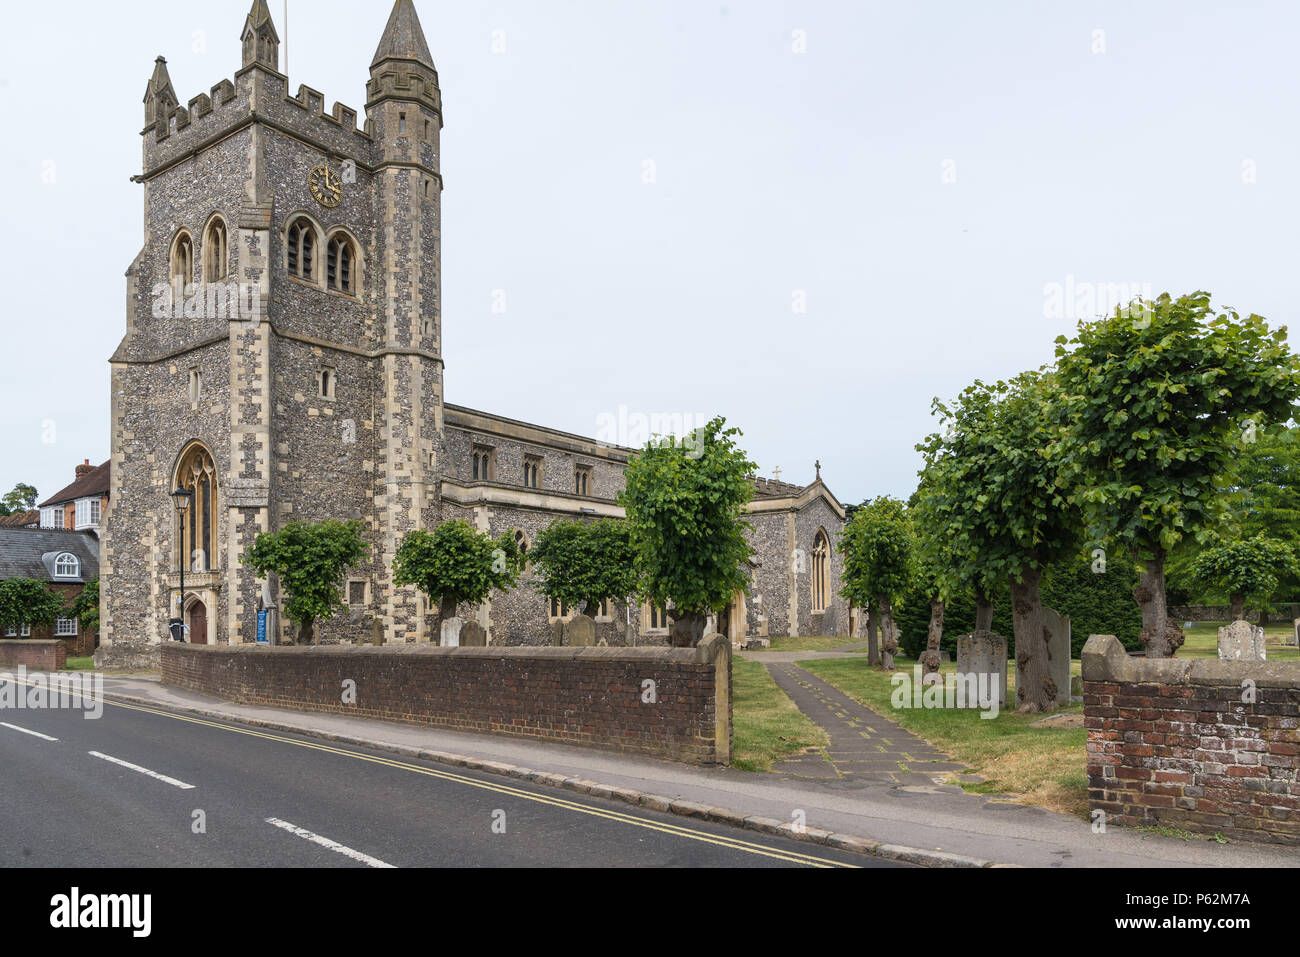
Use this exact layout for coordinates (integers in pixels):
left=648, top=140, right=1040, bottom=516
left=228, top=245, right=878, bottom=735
left=0, top=0, right=1300, bottom=502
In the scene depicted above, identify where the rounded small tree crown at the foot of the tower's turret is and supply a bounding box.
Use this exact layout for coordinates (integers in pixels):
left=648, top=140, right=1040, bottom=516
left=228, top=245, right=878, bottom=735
left=393, top=519, right=524, bottom=620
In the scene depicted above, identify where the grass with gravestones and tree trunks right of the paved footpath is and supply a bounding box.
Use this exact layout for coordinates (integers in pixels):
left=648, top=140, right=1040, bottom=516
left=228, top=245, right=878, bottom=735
left=801, top=658, right=1088, bottom=818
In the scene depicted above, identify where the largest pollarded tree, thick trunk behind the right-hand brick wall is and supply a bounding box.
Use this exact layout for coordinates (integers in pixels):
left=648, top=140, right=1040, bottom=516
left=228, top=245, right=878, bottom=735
left=1054, top=293, right=1300, bottom=658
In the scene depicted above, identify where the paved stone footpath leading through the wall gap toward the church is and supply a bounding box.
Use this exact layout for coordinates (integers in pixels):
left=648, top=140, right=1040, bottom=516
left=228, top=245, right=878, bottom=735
left=767, top=663, right=966, bottom=785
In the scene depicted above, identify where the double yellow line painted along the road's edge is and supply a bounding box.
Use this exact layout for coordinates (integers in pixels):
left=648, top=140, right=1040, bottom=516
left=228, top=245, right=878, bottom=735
left=15, top=670, right=857, bottom=867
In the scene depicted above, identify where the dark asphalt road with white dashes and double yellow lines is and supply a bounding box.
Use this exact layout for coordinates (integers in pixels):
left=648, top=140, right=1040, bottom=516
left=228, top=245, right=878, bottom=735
left=0, top=686, right=905, bottom=867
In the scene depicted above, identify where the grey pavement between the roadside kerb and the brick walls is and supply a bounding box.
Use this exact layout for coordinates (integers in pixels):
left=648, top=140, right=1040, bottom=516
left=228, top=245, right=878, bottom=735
left=48, top=653, right=1300, bottom=867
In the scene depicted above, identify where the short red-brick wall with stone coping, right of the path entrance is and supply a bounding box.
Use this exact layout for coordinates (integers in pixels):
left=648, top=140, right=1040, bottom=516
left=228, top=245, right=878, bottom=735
left=1082, top=635, right=1300, bottom=845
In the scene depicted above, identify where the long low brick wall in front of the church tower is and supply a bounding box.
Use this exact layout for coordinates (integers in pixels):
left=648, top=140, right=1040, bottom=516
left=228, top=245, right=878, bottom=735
left=161, top=635, right=732, bottom=765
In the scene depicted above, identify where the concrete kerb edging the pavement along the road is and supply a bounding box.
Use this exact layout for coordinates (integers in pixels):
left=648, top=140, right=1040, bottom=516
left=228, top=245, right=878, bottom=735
left=104, top=692, right=1018, bottom=867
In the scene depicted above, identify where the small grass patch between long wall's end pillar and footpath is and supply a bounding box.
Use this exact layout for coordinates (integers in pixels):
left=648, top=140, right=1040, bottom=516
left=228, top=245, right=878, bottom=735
left=732, top=658, right=828, bottom=771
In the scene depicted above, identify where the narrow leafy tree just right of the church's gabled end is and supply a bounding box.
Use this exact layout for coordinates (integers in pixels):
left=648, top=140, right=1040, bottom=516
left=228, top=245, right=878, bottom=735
left=840, top=495, right=915, bottom=670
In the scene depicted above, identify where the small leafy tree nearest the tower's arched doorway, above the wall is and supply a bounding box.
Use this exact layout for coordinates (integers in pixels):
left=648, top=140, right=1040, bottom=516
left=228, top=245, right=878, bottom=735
left=239, top=519, right=369, bottom=644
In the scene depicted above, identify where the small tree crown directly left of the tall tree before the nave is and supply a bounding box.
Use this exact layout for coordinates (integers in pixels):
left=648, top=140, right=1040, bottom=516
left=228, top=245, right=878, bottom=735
left=528, top=519, right=637, bottom=615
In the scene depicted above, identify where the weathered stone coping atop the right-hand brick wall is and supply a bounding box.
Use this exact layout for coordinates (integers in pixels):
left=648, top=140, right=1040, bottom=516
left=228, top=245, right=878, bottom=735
left=1080, top=635, right=1300, bottom=689
